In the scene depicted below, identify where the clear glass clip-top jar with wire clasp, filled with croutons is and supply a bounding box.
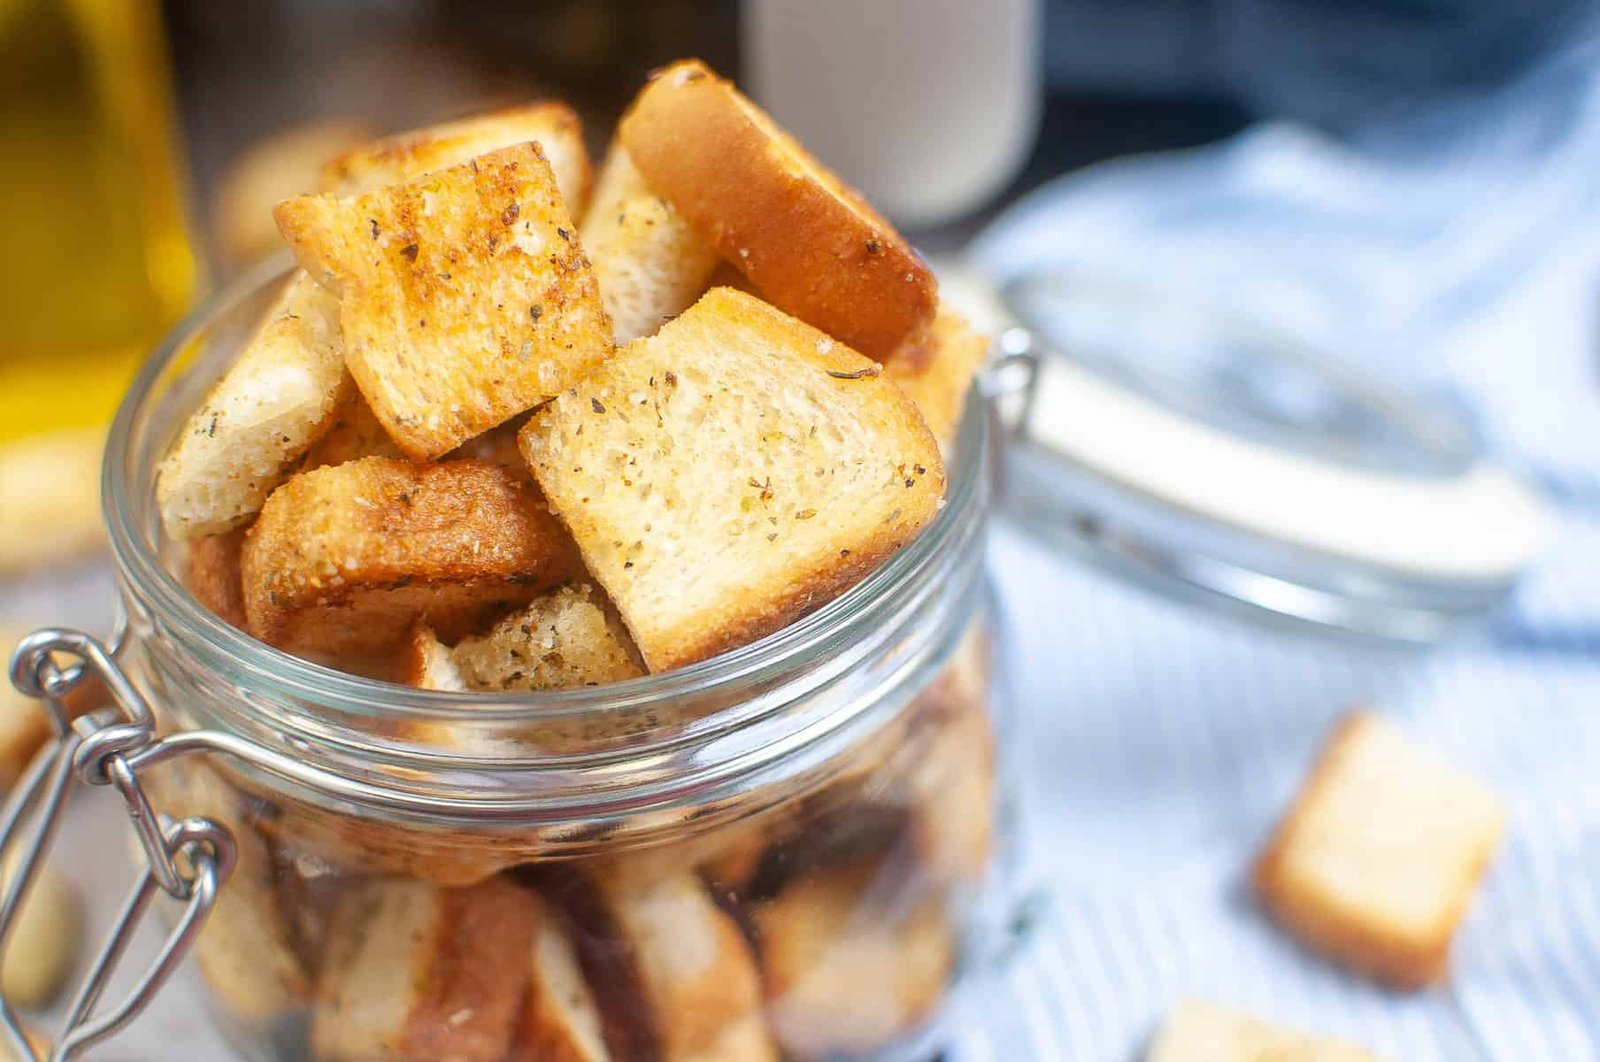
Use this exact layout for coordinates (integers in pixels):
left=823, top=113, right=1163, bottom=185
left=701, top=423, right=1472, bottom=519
left=13, top=259, right=1006, bottom=1060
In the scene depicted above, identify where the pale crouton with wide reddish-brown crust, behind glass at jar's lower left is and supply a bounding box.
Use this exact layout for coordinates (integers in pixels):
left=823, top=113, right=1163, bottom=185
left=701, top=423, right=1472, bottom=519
left=310, top=878, right=539, bottom=1062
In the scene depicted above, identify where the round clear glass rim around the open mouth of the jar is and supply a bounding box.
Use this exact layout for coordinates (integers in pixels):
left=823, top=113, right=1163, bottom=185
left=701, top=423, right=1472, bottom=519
left=101, top=256, right=989, bottom=738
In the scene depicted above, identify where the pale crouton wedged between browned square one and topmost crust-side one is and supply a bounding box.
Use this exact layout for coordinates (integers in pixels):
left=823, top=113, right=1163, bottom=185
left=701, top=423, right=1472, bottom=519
left=579, top=144, right=718, bottom=344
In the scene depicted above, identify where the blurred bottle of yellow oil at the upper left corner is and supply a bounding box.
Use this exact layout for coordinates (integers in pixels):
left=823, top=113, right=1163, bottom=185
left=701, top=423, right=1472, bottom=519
left=0, top=0, right=195, bottom=445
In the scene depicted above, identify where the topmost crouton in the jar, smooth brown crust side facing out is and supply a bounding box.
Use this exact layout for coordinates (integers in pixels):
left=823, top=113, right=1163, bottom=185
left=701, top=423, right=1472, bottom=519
left=618, top=61, right=936, bottom=358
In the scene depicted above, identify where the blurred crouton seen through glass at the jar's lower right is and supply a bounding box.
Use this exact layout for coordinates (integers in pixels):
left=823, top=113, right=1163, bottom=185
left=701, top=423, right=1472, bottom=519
left=750, top=860, right=955, bottom=1059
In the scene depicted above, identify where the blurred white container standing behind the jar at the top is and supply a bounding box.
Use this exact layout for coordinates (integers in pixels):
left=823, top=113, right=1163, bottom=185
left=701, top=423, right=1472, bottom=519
left=742, top=0, right=1042, bottom=226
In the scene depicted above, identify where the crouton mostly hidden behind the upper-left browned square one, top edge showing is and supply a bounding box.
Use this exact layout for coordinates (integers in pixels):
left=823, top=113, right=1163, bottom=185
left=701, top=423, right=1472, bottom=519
left=322, top=101, right=594, bottom=218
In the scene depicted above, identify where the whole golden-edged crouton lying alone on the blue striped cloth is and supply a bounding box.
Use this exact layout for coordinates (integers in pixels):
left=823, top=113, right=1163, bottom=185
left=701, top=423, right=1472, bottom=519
left=1254, top=712, right=1506, bottom=988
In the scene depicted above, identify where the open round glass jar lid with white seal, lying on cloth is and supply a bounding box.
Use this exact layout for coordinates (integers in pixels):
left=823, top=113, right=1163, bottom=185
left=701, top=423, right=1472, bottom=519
left=954, top=269, right=1544, bottom=643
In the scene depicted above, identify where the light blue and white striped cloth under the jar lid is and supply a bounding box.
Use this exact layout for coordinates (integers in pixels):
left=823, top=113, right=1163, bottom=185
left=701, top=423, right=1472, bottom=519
left=952, top=24, right=1600, bottom=1062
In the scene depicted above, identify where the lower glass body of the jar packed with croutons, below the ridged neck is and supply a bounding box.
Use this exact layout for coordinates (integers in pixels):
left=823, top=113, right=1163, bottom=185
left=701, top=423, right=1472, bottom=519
left=140, top=630, right=997, bottom=1062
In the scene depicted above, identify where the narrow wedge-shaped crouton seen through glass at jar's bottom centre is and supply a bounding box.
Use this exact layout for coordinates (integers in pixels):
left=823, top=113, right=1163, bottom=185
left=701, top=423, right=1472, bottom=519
left=510, top=896, right=611, bottom=1062
